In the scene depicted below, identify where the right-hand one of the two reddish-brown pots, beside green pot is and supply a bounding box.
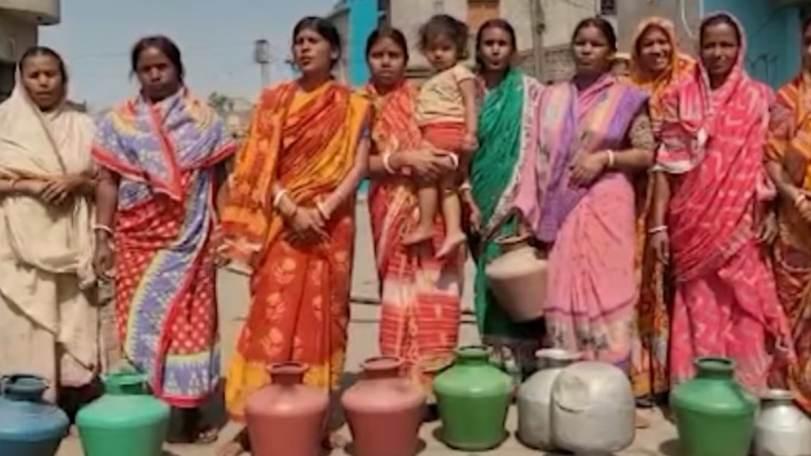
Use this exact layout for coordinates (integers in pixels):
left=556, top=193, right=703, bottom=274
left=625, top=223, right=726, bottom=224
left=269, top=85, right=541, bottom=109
left=341, top=356, right=426, bottom=456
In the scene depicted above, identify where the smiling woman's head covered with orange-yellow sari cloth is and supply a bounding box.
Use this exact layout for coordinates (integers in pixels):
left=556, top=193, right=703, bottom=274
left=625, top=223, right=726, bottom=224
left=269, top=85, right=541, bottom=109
left=631, top=17, right=695, bottom=110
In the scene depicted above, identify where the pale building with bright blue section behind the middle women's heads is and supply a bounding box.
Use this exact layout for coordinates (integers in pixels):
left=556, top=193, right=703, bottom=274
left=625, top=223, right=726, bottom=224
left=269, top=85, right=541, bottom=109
left=329, top=0, right=617, bottom=85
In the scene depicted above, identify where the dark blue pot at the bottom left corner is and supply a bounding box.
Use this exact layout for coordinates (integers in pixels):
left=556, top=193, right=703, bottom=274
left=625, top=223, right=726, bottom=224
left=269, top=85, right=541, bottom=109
left=0, top=375, right=70, bottom=456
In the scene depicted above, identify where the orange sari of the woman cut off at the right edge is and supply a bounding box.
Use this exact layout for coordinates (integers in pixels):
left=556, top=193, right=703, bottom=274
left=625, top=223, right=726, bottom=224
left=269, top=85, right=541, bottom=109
left=766, top=72, right=811, bottom=413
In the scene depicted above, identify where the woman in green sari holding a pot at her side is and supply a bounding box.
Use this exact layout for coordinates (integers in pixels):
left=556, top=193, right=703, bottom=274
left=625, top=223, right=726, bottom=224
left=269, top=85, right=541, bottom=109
left=467, top=19, right=544, bottom=374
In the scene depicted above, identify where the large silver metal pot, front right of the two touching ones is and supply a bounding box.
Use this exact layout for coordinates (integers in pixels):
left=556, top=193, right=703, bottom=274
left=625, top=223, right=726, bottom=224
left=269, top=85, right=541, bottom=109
left=552, top=361, right=636, bottom=454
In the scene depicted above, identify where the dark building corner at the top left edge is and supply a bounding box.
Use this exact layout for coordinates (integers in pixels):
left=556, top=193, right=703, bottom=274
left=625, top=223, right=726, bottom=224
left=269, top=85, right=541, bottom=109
left=0, top=0, right=60, bottom=101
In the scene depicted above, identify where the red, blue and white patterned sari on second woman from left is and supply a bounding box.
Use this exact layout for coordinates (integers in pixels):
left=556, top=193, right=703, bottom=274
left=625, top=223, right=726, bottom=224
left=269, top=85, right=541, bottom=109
left=93, top=89, right=235, bottom=407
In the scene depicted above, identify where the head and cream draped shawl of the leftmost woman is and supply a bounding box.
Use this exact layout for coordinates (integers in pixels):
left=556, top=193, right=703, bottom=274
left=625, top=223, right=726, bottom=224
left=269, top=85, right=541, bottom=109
left=0, top=46, right=95, bottom=282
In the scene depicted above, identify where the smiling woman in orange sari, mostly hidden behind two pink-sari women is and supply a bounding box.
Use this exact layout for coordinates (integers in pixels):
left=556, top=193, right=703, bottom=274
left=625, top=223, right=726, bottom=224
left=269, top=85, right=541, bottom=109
left=630, top=17, right=695, bottom=405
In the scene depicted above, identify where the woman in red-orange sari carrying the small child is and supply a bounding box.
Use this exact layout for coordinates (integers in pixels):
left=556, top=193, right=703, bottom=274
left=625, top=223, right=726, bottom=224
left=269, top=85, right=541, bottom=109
left=362, top=28, right=463, bottom=391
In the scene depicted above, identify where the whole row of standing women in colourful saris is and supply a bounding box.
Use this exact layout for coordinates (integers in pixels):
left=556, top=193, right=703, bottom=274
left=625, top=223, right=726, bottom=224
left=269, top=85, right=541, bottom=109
left=0, top=6, right=811, bottom=454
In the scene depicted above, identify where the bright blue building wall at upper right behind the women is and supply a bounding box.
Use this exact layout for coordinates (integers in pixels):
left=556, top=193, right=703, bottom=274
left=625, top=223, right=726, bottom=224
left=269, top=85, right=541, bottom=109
left=704, top=0, right=800, bottom=87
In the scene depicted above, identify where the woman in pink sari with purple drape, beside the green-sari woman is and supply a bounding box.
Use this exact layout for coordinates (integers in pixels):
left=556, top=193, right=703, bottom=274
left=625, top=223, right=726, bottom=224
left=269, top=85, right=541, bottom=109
left=516, top=18, right=654, bottom=371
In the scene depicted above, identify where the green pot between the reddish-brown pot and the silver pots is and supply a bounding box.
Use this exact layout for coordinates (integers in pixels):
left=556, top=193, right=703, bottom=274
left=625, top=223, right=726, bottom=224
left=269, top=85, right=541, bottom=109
left=434, top=346, right=513, bottom=451
